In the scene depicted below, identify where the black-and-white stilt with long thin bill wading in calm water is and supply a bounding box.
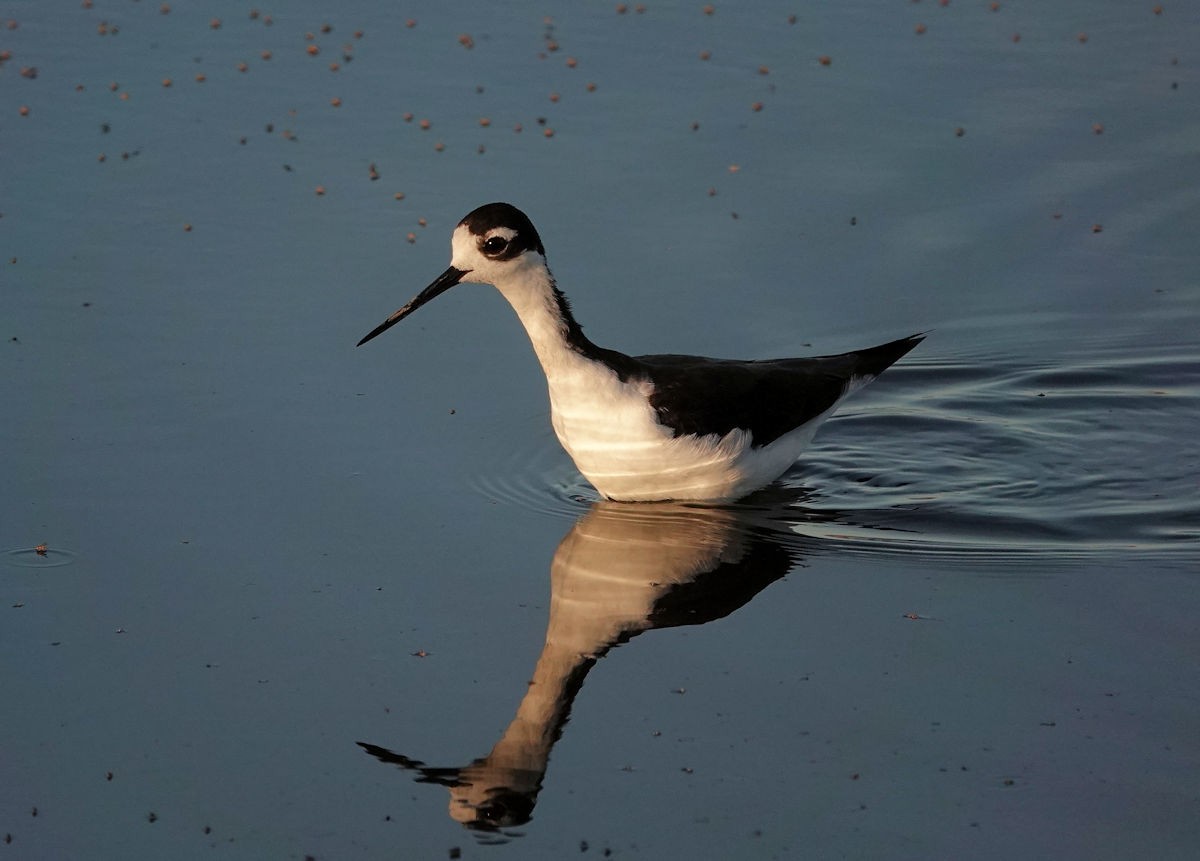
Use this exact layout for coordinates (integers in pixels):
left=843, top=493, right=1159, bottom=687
left=358, top=203, right=925, bottom=504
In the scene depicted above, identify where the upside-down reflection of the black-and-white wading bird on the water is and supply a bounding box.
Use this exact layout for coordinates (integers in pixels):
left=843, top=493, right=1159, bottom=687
left=359, top=501, right=820, bottom=839
